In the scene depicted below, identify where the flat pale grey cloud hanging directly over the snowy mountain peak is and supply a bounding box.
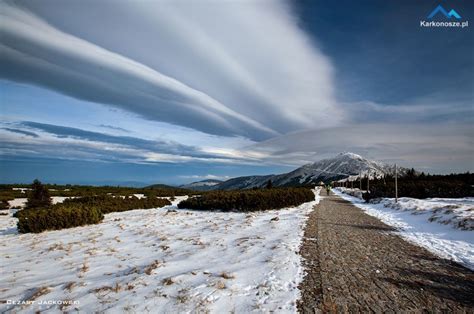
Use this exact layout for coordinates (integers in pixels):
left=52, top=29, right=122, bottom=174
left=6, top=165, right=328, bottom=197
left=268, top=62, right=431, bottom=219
left=246, top=122, right=474, bottom=172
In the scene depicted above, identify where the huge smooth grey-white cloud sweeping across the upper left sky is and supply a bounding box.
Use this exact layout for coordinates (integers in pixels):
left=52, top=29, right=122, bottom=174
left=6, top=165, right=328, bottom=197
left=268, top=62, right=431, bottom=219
left=0, top=1, right=342, bottom=140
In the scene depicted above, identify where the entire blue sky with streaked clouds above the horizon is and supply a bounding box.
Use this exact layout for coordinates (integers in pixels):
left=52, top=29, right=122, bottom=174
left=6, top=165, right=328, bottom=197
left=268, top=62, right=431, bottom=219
left=0, top=0, right=474, bottom=185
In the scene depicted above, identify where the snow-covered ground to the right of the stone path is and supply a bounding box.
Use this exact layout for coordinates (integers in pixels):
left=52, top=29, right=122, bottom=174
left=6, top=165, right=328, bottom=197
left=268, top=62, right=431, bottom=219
left=334, top=188, right=474, bottom=270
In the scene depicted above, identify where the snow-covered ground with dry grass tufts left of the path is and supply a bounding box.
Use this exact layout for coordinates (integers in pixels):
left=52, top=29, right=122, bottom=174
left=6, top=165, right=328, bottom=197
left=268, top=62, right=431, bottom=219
left=0, top=192, right=319, bottom=313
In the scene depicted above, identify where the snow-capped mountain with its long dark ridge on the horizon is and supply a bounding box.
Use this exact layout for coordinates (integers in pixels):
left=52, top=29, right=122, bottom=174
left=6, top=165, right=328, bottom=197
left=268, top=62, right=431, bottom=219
left=212, top=153, right=407, bottom=190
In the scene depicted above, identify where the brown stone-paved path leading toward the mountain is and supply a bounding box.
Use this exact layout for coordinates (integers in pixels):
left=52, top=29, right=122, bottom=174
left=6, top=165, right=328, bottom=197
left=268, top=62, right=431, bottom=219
left=298, top=196, right=474, bottom=313
